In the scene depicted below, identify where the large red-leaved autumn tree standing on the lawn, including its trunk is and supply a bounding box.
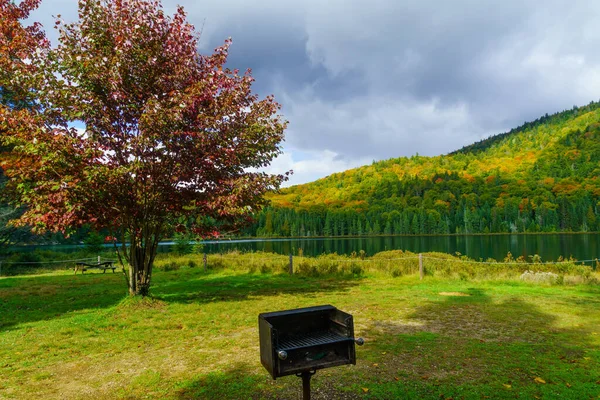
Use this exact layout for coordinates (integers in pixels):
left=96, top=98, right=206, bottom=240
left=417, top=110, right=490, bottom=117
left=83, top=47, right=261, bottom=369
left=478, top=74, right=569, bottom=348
left=1, top=0, right=286, bottom=295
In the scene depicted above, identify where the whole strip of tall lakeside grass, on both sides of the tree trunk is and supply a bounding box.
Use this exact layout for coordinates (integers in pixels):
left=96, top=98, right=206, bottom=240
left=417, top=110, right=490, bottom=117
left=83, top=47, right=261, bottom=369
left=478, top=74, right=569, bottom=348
left=2, top=249, right=600, bottom=284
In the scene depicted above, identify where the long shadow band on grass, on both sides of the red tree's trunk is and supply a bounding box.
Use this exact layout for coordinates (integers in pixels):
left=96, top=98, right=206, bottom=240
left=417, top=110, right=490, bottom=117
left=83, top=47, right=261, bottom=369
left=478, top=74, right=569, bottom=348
left=0, top=269, right=357, bottom=332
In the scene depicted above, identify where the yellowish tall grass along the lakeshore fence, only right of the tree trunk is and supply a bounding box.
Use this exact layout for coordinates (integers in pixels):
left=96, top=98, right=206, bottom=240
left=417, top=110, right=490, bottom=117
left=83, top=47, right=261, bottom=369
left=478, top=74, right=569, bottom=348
left=150, top=250, right=599, bottom=284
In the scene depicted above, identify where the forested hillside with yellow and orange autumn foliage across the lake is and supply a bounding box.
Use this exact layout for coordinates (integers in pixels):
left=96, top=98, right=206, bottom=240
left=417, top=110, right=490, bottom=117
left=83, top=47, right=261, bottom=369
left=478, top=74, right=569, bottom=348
left=245, top=102, right=600, bottom=236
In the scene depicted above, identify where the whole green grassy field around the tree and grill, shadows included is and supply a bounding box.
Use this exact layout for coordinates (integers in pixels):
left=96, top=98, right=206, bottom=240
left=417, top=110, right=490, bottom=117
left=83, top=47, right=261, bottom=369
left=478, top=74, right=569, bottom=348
left=0, top=255, right=600, bottom=399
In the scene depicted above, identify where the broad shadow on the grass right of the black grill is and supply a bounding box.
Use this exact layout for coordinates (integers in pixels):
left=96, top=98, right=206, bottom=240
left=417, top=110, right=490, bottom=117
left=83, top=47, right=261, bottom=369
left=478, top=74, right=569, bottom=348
left=360, top=289, right=600, bottom=399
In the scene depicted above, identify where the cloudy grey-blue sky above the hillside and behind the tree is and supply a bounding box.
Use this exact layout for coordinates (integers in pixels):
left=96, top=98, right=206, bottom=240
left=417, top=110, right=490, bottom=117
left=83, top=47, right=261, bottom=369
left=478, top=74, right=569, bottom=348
left=32, top=0, right=600, bottom=185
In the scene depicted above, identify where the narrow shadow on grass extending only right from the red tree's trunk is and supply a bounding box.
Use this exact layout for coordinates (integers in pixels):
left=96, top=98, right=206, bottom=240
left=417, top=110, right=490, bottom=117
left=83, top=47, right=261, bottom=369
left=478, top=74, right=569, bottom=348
left=152, top=273, right=360, bottom=303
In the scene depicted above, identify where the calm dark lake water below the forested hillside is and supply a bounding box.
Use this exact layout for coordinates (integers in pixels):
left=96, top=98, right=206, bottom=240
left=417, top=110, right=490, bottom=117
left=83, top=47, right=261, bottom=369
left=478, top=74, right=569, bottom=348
left=9, top=234, right=600, bottom=261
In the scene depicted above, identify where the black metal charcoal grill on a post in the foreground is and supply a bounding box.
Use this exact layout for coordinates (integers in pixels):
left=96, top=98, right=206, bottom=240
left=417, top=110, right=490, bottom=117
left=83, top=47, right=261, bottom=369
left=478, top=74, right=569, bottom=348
left=258, top=305, right=364, bottom=400
